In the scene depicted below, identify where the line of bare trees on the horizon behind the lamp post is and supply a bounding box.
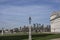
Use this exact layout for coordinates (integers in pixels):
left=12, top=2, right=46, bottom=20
left=10, top=24, right=51, bottom=32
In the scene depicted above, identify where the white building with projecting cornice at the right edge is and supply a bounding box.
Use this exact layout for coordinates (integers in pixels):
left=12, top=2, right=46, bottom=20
left=50, top=12, right=60, bottom=32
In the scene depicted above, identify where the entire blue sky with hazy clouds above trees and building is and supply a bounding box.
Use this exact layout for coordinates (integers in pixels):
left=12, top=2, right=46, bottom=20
left=0, top=0, right=60, bottom=29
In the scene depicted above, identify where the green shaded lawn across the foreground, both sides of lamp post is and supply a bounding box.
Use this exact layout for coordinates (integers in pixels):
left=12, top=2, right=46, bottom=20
left=0, top=33, right=60, bottom=40
